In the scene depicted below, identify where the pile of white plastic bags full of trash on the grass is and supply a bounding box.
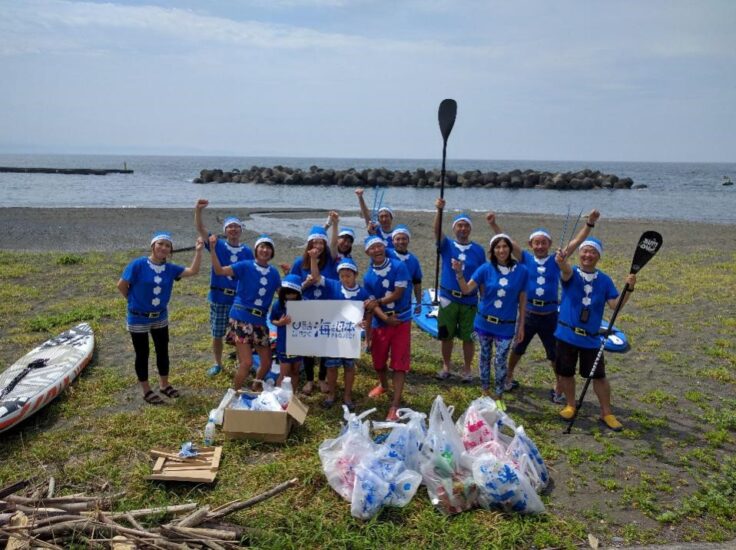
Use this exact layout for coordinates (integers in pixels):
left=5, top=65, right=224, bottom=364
left=319, top=395, right=549, bottom=519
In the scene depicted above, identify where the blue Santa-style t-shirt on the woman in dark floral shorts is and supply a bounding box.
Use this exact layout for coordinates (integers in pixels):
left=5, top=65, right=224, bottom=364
left=230, top=260, right=281, bottom=325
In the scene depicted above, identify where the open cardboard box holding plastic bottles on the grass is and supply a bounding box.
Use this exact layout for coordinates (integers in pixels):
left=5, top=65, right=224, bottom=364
left=222, top=392, right=309, bottom=443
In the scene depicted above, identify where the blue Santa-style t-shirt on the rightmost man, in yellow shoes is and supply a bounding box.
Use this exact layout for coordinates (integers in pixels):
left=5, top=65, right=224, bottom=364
left=555, top=266, right=618, bottom=348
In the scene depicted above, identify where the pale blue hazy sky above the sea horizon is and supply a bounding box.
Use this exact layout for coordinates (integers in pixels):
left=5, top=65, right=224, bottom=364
left=0, top=0, right=736, bottom=162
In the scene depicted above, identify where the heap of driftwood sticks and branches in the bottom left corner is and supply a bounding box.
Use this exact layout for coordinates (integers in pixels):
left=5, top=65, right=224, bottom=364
left=0, top=476, right=298, bottom=550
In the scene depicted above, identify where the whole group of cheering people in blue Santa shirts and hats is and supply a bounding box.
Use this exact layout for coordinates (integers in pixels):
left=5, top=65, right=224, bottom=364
left=118, top=189, right=636, bottom=431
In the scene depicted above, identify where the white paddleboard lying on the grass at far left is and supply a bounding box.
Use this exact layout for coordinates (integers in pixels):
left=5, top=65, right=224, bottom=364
left=0, top=323, right=95, bottom=432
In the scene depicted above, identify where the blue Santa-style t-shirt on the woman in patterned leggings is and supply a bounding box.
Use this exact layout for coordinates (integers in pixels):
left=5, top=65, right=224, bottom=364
left=471, top=262, right=528, bottom=338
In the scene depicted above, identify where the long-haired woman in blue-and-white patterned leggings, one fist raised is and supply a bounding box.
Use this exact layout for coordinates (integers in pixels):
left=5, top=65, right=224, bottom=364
left=452, top=233, right=528, bottom=399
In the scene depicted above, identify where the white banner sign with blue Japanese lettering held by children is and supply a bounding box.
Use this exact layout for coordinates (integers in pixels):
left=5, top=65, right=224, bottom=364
left=286, top=300, right=363, bottom=359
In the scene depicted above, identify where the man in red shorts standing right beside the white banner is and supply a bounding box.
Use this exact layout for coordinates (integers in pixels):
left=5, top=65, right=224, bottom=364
left=363, top=235, right=412, bottom=421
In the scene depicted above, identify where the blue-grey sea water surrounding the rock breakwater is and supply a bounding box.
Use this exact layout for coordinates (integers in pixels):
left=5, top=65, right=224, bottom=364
left=0, top=155, right=736, bottom=224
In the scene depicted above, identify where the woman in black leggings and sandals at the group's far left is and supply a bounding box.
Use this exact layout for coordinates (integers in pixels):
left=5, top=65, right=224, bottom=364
left=117, top=232, right=204, bottom=405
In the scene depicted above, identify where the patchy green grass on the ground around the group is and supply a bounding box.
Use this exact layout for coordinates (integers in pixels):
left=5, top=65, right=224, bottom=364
left=0, top=210, right=736, bottom=549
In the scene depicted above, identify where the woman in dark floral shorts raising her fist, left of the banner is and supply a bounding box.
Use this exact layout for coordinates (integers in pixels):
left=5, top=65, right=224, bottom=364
left=210, top=235, right=281, bottom=390
